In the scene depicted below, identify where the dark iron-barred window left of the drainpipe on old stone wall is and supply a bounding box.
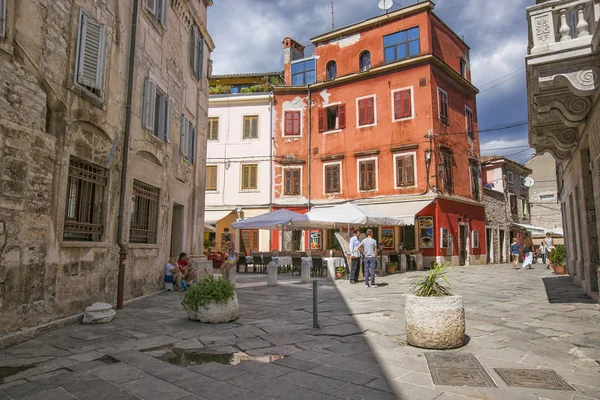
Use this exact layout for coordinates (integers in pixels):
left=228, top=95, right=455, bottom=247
left=63, top=159, right=108, bottom=242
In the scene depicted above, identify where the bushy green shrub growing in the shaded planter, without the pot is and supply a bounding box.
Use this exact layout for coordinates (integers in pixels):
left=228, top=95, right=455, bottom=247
left=181, top=275, right=235, bottom=310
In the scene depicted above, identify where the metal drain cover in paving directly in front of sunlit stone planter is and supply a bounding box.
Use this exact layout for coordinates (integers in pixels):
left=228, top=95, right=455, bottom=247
left=425, top=352, right=496, bottom=387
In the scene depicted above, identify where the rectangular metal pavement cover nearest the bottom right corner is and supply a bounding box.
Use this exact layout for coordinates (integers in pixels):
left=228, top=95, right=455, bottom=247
left=494, top=368, right=575, bottom=390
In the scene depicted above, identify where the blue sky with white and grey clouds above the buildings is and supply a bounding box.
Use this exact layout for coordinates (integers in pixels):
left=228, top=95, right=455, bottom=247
left=208, top=0, right=535, bottom=163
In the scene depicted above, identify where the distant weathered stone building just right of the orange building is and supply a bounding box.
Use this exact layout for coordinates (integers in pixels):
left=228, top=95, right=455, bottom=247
left=481, top=156, right=532, bottom=263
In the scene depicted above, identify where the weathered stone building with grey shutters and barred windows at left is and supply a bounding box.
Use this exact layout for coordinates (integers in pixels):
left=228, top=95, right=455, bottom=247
left=0, top=0, right=214, bottom=335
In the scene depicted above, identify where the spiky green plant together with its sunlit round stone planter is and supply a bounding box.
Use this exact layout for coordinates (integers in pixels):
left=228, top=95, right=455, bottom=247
left=405, top=263, right=465, bottom=349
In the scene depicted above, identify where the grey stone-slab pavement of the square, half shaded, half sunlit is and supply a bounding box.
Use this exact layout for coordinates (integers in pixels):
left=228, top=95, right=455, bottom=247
left=0, top=265, right=600, bottom=400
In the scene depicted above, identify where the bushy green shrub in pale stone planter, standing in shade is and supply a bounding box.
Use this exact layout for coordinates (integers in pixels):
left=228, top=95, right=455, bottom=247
left=181, top=271, right=240, bottom=324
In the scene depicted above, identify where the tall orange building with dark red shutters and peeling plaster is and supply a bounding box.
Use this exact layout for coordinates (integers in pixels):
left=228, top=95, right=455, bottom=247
left=273, top=1, right=486, bottom=266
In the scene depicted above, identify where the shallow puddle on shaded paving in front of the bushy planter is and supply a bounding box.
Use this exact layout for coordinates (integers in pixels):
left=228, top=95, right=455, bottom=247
left=158, top=349, right=285, bottom=366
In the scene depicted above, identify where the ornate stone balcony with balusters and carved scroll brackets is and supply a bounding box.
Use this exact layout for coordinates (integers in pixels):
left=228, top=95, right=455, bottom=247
left=526, top=0, right=600, bottom=161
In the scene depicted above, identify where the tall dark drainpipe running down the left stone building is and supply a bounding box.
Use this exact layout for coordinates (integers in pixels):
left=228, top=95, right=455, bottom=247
left=117, top=0, right=139, bottom=310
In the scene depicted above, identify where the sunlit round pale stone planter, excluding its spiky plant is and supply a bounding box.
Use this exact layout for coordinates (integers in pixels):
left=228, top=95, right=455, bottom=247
left=405, top=295, right=465, bottom=350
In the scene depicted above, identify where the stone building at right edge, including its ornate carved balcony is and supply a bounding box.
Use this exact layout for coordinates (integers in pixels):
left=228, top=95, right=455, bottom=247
left=526, top=0, right=600, bottom=300
